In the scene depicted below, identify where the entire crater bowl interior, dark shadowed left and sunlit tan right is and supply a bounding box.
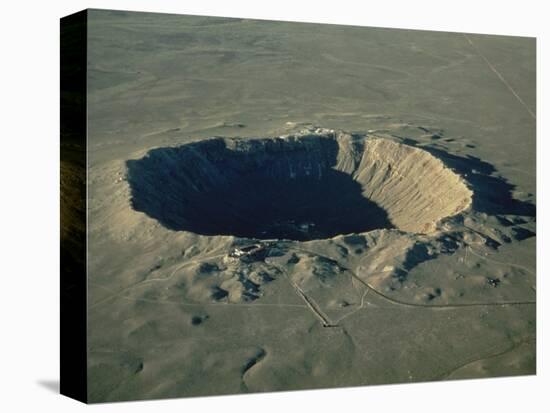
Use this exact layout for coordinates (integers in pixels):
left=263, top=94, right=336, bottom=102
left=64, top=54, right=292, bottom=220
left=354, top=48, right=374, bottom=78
left=127, top=130, right=471, bottom=241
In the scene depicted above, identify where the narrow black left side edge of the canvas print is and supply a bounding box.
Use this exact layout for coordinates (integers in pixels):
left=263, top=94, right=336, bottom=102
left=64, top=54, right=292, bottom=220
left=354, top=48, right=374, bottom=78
left=60, top=10, right=88, bottom=403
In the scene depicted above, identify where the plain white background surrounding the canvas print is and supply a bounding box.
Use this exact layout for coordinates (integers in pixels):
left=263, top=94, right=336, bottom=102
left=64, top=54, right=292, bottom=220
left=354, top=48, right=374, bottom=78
left=0, top=0, right=550, bottom=413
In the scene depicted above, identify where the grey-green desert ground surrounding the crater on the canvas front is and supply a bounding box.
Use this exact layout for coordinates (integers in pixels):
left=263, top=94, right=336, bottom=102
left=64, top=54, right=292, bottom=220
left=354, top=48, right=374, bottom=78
left=84, top=11, right=536, bottom=402
